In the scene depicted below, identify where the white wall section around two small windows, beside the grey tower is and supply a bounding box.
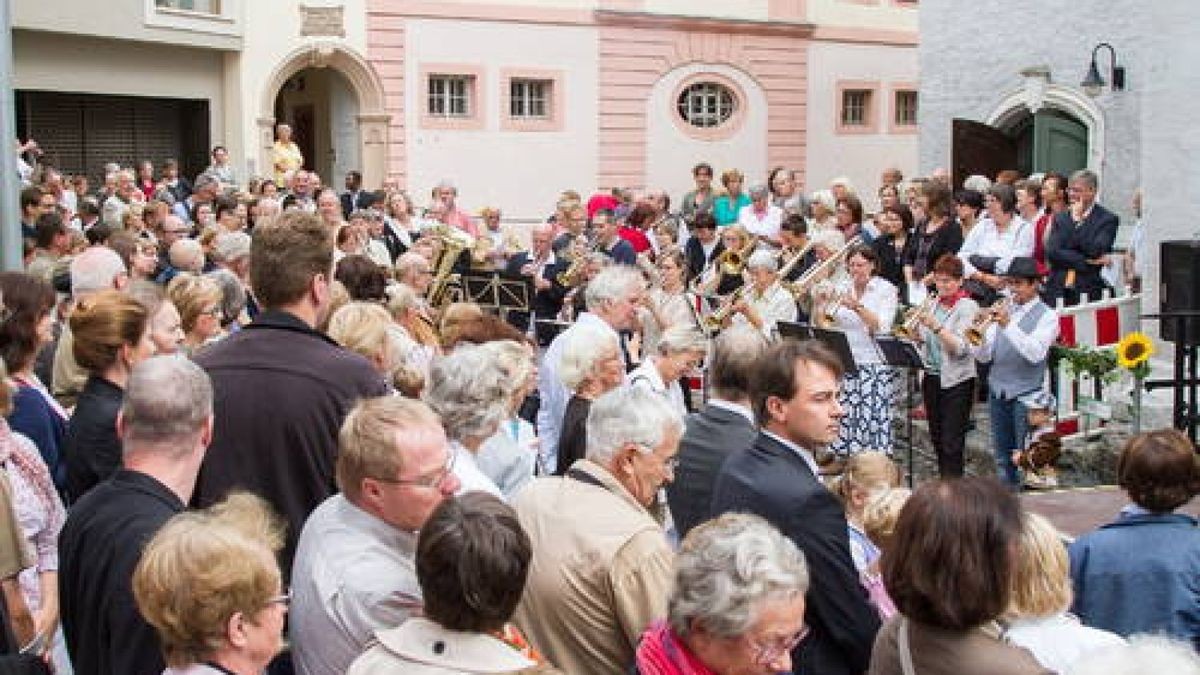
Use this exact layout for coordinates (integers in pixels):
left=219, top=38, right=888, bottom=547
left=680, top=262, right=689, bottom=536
left=805, top=42, right=919, bottom=209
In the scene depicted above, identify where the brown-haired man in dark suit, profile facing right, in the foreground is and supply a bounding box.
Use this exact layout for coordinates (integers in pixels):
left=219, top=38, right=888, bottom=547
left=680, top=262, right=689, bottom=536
left=712, top=340, right=880, bottom=675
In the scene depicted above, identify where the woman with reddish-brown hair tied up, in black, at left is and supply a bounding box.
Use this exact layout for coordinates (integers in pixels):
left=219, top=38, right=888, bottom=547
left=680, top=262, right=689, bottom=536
left=62, top=291, right=155, bottom=500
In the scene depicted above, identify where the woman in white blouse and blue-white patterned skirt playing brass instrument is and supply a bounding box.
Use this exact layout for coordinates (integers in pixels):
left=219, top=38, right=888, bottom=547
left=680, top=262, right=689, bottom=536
left=826, top=246, right=899, bottom=455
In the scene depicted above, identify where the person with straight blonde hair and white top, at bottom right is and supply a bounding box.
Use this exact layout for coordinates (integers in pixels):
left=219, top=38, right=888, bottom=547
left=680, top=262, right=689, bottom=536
left=1004, top=513, right=1124, bottom=673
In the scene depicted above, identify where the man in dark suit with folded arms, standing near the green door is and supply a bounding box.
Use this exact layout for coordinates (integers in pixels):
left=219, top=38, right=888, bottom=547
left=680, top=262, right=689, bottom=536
left=1044, top=169, right=1120, bottom=306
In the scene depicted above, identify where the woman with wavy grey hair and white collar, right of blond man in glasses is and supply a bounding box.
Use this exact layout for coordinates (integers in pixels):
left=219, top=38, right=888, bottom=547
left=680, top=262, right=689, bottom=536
left=421, top=345, right=510, bottom=498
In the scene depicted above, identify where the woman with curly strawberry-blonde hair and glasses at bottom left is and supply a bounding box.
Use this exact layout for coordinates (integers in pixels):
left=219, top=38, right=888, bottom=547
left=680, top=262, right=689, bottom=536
left=133, top=492, right=292, bottom=675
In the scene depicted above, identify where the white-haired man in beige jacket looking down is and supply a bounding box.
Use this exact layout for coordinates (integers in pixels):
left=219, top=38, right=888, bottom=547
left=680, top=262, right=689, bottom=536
left=512, top=389, right=683, bottom=675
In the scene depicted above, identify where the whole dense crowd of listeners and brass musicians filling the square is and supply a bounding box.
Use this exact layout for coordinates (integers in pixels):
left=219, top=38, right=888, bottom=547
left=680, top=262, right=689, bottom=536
left=0, top=136, right=1185, bottom=675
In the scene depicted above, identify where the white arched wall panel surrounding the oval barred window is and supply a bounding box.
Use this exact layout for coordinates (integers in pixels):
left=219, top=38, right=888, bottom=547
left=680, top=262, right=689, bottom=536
left=646, top=64, right=767, bottom=204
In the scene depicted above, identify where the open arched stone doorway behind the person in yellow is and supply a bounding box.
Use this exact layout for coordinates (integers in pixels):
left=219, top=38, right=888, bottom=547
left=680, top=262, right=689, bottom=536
left=257, top=43, right=390, bottom=189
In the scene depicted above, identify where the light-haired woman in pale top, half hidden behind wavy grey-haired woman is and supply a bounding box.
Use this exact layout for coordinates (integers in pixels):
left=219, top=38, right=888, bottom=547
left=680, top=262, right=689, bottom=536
left=475, top=340, right=538, bottom=498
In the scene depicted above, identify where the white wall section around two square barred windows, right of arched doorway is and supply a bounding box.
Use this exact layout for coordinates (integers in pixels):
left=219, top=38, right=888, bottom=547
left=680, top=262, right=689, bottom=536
left=404, top=19, right=599, bottom=219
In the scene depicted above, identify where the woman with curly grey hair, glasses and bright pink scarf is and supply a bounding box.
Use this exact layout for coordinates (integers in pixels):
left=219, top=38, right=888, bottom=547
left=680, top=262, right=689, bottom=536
left=636, top=513, right=809, bottom=675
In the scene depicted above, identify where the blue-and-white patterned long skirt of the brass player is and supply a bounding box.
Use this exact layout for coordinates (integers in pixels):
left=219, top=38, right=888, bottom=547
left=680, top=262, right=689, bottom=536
left=829, top=364, right=896, bottom=455
